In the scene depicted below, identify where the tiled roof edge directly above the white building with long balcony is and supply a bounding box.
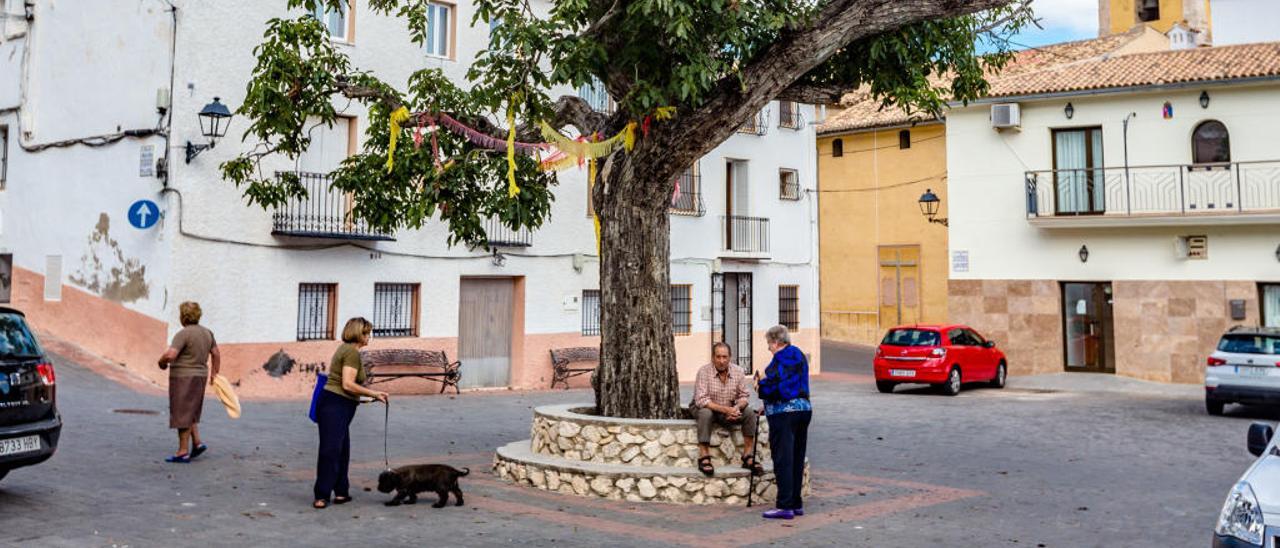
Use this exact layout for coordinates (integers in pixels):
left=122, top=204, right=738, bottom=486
left=988, top=42, right=1280, bottom=97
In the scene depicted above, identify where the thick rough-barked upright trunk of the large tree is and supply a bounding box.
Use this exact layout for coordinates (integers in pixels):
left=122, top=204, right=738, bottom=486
left=594, top=149, right=680, bottom=419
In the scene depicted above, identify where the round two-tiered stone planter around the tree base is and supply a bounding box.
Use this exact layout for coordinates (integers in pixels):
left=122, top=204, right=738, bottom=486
left=493, top=405, right=809, bottom=504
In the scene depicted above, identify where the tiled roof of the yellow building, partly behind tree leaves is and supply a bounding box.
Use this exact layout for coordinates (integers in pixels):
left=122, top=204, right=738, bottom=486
left=818, top=27, right=1169, bottom=134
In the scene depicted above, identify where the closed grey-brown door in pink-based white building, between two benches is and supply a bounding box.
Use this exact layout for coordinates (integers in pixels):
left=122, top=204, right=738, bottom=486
left=458, top=278, right=515, bottom=388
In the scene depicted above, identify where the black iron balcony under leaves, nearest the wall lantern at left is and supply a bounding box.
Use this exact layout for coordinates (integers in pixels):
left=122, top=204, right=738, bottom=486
left=271, top=172, right=396, bottom=241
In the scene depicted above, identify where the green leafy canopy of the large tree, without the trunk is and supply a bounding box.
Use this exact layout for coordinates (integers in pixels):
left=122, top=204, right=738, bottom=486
left=223, top=0, right=1030, bottom=246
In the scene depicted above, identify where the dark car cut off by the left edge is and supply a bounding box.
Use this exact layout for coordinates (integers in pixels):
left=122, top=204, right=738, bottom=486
left=0, top=307, right=63, bottom=478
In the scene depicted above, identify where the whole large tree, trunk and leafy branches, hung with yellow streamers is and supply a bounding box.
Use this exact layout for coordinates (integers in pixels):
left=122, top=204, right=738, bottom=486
left=223, top=0, right=1032, bottom=419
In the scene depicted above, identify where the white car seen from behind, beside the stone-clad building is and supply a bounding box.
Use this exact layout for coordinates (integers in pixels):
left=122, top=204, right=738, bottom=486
left=1204, top=326, right=1280, bottom=415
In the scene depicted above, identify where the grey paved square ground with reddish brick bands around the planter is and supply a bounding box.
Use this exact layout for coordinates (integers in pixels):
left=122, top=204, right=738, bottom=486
left=0, top=346, right=1276, bottom=547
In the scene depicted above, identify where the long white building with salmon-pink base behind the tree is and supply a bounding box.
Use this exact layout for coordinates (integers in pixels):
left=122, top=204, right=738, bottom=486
left=0, top=0, right=819, bottom=396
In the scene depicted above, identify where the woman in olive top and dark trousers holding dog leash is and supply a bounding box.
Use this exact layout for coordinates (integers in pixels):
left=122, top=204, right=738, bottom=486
left=311, top=318, right=387, bottom=510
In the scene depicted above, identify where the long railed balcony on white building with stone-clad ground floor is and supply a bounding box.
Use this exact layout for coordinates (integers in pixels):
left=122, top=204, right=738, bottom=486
left=1025, top=160, right=1280, bottom=228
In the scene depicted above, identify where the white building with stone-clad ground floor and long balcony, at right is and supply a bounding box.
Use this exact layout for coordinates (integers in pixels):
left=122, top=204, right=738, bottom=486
left=947, top=44, right=1280, bottom=383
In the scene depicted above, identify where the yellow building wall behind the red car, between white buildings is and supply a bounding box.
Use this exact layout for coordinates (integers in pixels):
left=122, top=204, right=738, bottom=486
left=818, top=122, right=947, bottom=344
